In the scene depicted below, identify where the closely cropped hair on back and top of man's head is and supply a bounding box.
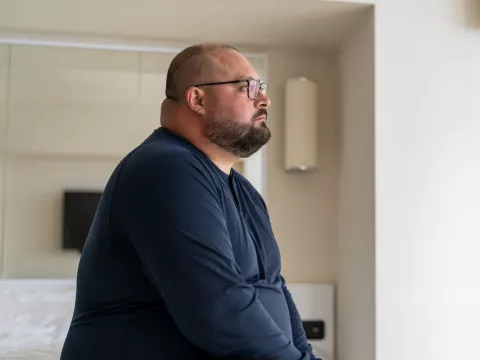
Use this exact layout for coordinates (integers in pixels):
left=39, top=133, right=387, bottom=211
left=165, top=44, right=238, bottom=100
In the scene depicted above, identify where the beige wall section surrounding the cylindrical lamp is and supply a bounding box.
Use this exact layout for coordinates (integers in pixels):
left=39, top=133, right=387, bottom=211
left=267, top=48, right=339, bottom=282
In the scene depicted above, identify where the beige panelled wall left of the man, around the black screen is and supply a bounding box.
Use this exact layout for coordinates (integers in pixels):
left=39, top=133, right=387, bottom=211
left=0, top=45, right=265, bottom=278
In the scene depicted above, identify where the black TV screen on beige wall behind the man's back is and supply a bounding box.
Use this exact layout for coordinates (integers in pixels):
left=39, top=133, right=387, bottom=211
left=63, top=190, right=102, bottom=252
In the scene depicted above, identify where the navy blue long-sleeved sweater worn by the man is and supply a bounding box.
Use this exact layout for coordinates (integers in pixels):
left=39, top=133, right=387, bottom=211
left=61, top=128, right=314, bottom=360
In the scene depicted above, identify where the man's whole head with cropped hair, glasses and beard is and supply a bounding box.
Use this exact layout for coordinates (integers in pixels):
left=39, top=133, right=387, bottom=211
left=160, top=44, right=270, bottom=162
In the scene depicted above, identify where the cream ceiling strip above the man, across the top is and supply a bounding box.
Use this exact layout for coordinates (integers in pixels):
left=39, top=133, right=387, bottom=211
left=0, top=0, right=369, bottom=47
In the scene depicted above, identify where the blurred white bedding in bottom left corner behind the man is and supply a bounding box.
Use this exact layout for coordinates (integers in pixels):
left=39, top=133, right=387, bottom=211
left=0, top=279, right=75, bottom=360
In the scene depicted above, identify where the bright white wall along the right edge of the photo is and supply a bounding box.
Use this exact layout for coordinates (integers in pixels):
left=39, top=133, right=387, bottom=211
left=375, top=0, right=480, bottom=360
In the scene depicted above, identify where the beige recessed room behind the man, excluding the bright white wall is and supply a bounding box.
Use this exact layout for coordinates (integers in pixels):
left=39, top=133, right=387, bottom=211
left=0, top=0, right=375, bottom=360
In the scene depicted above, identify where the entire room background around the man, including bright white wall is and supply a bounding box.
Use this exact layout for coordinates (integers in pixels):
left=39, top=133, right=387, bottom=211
left=0, top=0, right=480, bottom=360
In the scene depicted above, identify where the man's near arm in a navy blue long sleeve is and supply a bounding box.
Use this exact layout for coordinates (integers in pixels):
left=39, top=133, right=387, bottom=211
left=114, top=154, right=302, bottom=360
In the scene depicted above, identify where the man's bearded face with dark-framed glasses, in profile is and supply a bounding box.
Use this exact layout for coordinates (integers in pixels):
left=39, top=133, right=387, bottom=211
left=204, top=50, right=271, bottom=158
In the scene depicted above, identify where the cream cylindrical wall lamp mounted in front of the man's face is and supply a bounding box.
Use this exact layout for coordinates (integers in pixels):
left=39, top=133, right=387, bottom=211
left=285, top=77, right=318, bottom=172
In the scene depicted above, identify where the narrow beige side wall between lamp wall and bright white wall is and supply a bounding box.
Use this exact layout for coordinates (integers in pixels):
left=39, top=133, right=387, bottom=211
left=336, top=11, right=375, bottom=360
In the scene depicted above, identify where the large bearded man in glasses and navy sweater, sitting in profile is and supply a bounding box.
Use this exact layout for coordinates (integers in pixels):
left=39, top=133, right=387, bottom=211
left=61, top=44, right=315, bottom=360
